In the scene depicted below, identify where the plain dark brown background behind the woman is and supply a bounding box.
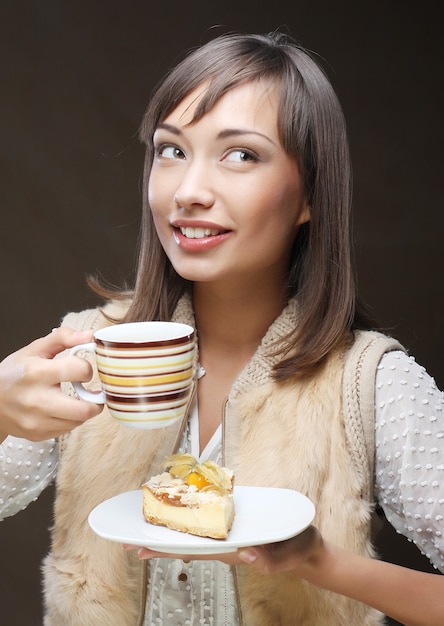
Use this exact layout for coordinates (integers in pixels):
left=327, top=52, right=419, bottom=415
left=0, top=0, right=444, bottom=626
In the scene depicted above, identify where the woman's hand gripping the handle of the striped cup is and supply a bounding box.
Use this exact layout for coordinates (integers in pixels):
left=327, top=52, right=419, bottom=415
left=0, top=328, right=103, bottom=442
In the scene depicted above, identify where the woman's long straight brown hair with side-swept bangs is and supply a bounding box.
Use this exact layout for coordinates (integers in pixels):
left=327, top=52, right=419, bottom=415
left=92, top=32, right=376, bottom=380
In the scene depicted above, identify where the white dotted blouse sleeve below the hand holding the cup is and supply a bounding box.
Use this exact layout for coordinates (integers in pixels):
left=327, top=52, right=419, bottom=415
left=0, top=437, right=58, bottom=520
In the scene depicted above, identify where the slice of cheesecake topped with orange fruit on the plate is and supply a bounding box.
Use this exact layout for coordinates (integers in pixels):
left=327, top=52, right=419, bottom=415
left=142, top=454, right=234, bottom=539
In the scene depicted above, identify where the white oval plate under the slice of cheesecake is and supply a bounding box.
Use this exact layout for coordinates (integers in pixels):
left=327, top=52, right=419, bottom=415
left=88, top=486, right=315, bottom=554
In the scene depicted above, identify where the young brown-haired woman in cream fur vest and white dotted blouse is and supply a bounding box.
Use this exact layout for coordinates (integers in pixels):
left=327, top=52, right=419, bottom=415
left=0, top=33, right=444, bottom=626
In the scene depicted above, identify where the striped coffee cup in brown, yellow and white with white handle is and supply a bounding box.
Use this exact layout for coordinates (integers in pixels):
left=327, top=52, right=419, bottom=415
left=70, top=321, right=195, bottom=429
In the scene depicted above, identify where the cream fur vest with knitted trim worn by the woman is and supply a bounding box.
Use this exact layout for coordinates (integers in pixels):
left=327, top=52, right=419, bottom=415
left=43, top=297, right=401, bottom=626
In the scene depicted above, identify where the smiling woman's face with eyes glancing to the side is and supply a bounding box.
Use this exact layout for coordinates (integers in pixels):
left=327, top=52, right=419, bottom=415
left=149, top=82, right=309, bottom=286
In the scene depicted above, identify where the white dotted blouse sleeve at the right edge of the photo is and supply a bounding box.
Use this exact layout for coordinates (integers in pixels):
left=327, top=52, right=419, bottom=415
left=375, top=351, right=444, bottom=572
